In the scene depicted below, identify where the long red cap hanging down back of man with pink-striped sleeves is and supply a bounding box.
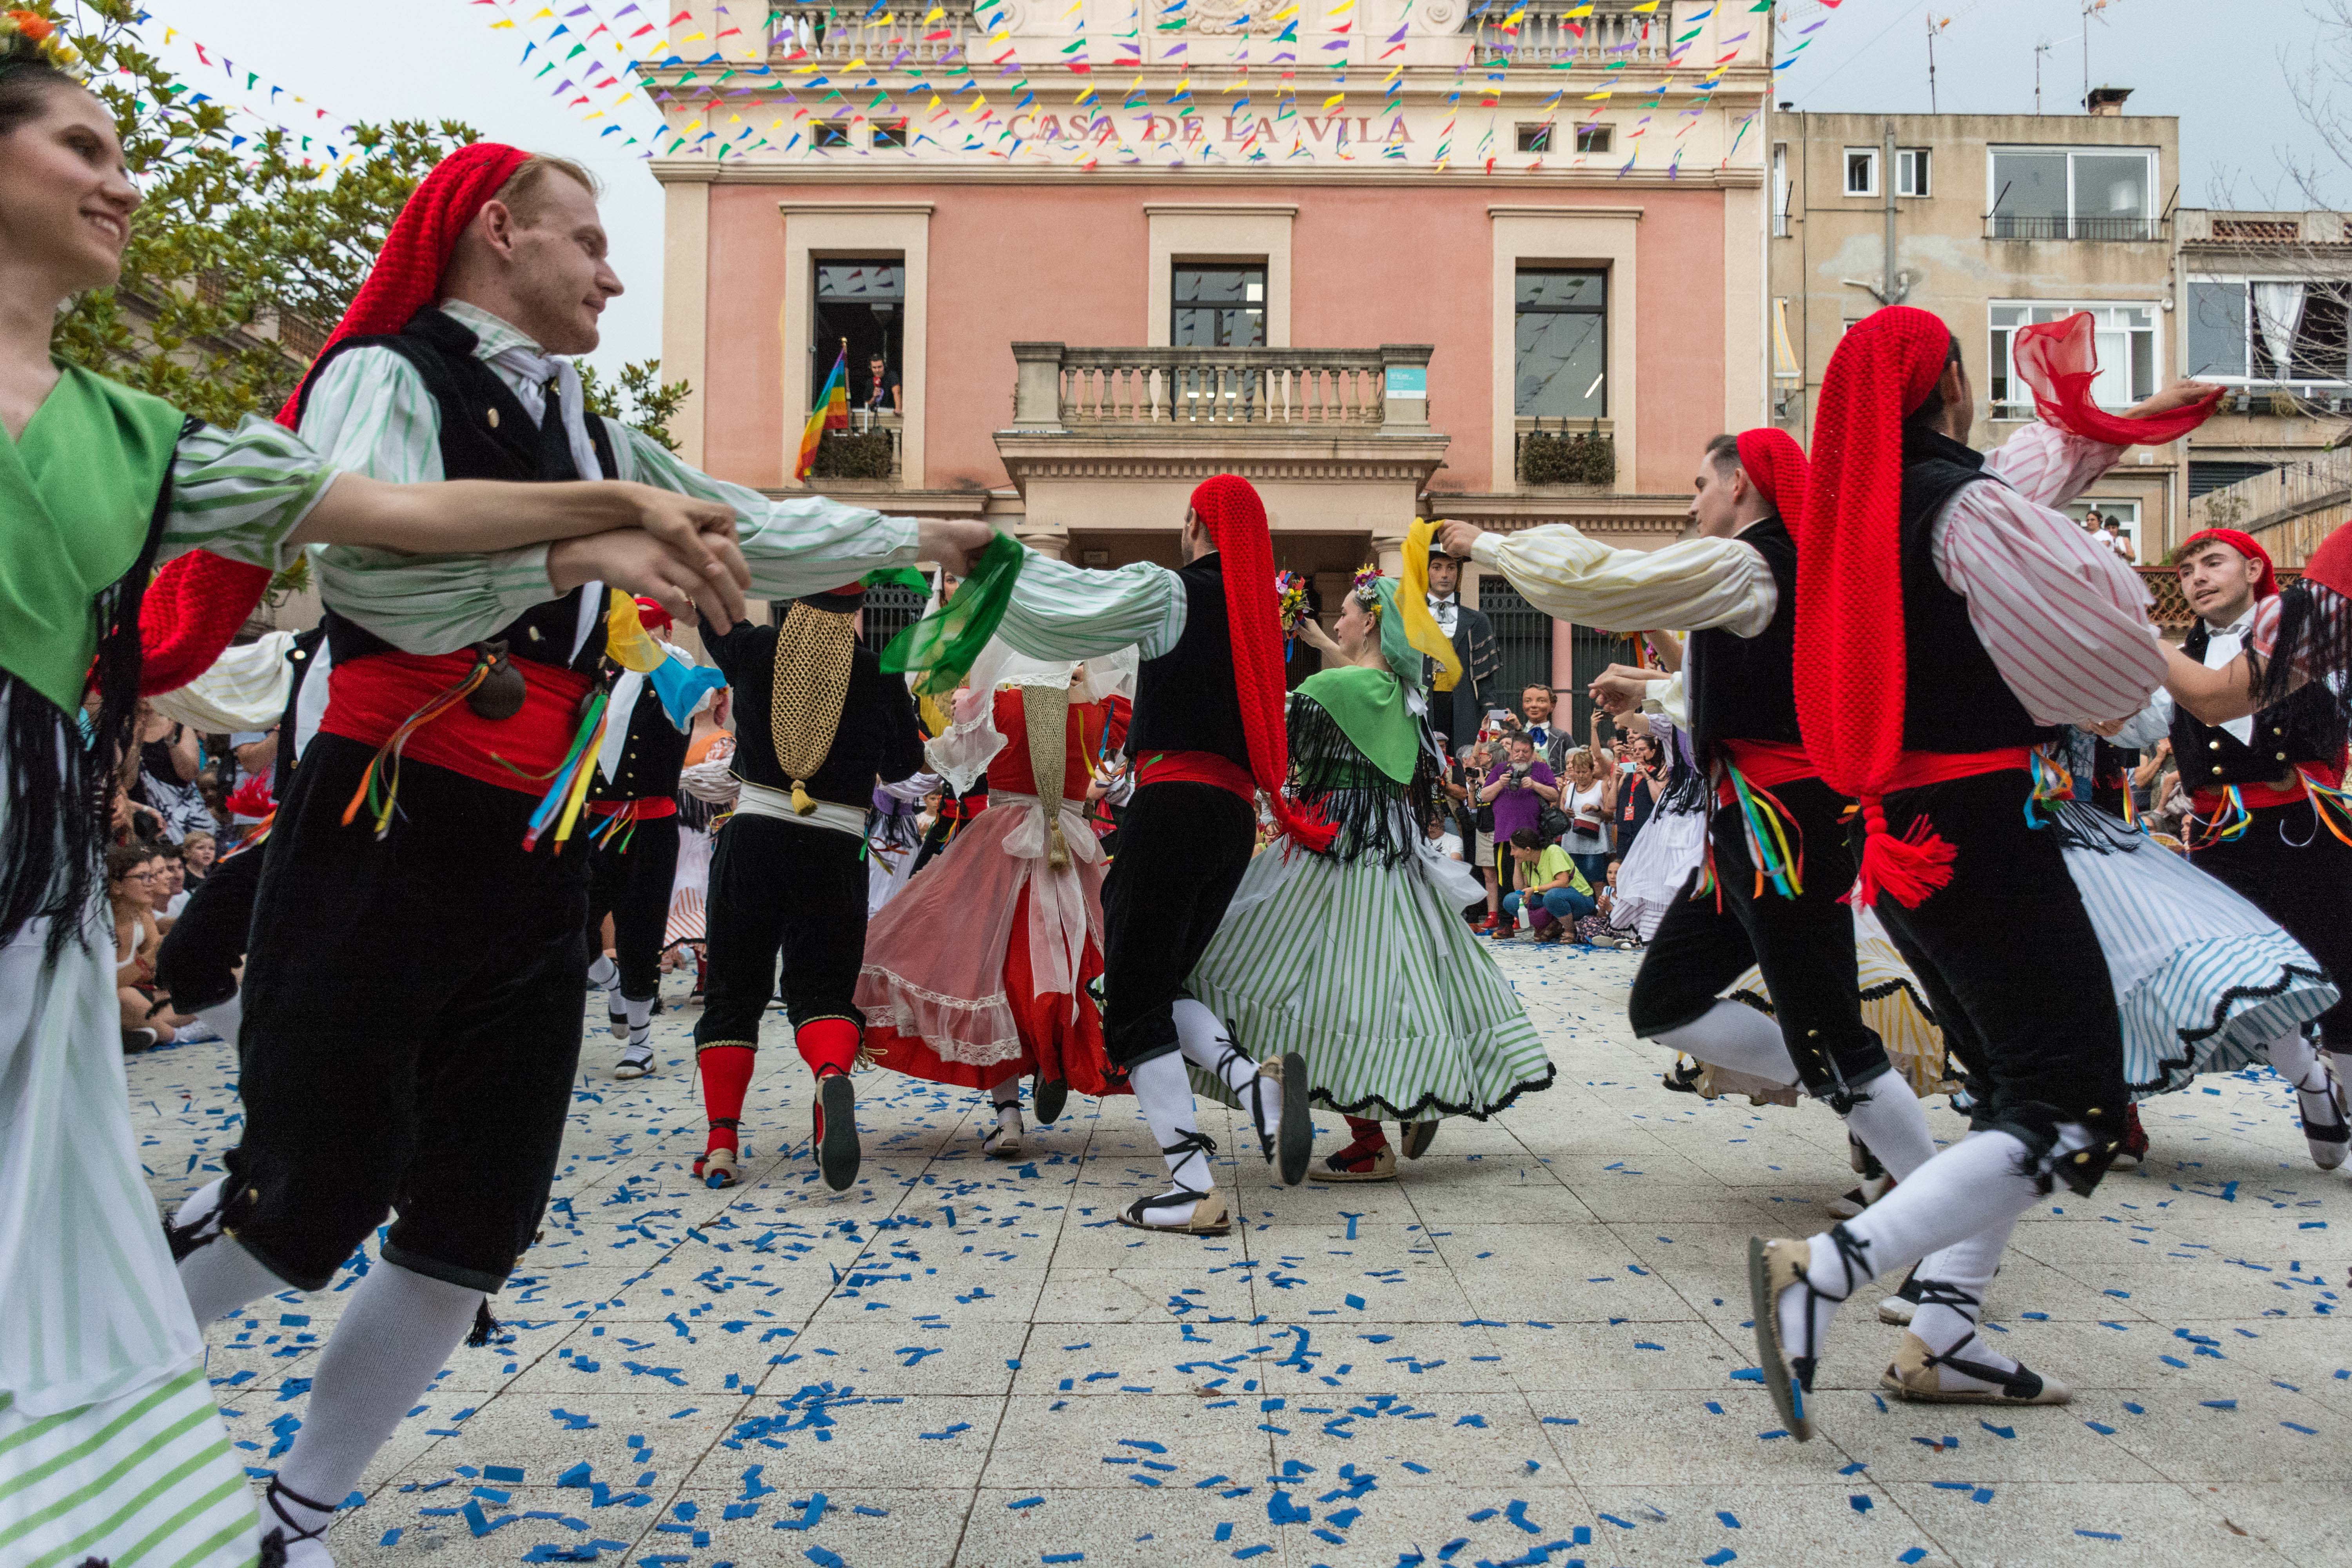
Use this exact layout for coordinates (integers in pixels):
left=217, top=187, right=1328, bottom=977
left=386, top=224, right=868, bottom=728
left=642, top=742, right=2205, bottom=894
left=1790, top=306, right=1952, bottom=795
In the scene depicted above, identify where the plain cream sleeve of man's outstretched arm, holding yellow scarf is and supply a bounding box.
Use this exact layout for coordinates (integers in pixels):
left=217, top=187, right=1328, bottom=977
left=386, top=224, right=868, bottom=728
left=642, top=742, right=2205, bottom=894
left=1470, top=522, right=1780, bottom=637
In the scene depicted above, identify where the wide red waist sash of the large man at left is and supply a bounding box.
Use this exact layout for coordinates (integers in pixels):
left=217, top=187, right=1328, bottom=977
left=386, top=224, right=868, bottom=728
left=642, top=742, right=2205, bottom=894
left=318, top=651, right=593, bottom=811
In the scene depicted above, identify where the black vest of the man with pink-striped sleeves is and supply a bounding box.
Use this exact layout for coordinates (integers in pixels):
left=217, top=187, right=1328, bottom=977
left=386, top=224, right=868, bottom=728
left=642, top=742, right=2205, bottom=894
left=1903, top=425, right=2058, bottom=752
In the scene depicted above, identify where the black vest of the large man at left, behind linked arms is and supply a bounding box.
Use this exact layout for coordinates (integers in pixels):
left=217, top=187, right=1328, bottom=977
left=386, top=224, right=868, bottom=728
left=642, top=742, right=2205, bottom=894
left=301, top=308, right=619, bottom=675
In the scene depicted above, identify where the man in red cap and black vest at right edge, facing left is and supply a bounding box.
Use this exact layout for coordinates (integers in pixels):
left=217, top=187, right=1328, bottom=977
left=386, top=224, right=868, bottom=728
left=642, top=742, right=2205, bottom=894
left=2117, top=529, right=2352, bottom=1171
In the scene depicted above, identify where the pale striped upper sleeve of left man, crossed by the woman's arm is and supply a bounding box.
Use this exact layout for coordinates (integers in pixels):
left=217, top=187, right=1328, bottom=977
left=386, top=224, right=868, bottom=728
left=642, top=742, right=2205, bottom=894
left=301, top=348, right=555, bottom=653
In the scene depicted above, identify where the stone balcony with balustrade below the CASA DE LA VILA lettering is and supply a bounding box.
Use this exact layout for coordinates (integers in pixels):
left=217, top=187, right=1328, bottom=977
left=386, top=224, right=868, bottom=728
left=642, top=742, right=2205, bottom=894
left=995, top=343, right=1449, bottom=543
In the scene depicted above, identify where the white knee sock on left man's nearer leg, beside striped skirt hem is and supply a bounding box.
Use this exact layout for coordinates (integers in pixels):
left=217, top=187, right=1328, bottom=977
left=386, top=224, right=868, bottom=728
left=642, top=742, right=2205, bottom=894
left=261, top=1260, right=482, bottom=1528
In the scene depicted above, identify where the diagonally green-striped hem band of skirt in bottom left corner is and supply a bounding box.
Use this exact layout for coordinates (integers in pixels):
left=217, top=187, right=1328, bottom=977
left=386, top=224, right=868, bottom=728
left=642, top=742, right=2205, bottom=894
left=0, top=1366, right=261, bottom=1568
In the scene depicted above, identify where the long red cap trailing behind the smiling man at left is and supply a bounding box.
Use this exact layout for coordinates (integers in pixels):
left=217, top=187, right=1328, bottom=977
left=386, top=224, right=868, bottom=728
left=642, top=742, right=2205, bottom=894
left=139, top=141, right=529, bottom=696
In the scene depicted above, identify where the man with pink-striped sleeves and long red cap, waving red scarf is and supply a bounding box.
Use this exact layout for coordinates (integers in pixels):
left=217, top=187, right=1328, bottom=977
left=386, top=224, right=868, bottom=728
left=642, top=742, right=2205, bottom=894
left=1750, top=306, right=2218, bottom=1439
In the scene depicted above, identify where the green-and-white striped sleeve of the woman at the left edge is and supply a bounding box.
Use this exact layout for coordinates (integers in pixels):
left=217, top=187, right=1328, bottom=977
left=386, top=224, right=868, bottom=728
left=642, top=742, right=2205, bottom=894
left=158, top=414, right=334, bottom=571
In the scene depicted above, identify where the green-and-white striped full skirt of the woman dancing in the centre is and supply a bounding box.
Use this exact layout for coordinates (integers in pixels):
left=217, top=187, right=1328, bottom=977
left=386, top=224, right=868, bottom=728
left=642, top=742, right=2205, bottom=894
left=1188, top=839, right=1552, bottom=1122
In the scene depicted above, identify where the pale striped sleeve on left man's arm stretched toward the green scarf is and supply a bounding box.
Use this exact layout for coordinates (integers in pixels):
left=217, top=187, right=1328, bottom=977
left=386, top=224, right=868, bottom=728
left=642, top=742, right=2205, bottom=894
left=604, top=418, right=917, bottom=599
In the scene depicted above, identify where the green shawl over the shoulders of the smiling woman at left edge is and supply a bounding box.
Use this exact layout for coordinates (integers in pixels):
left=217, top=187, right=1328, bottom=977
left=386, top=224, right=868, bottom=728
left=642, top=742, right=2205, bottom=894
left=0, top=362, right=186, bottom=712
